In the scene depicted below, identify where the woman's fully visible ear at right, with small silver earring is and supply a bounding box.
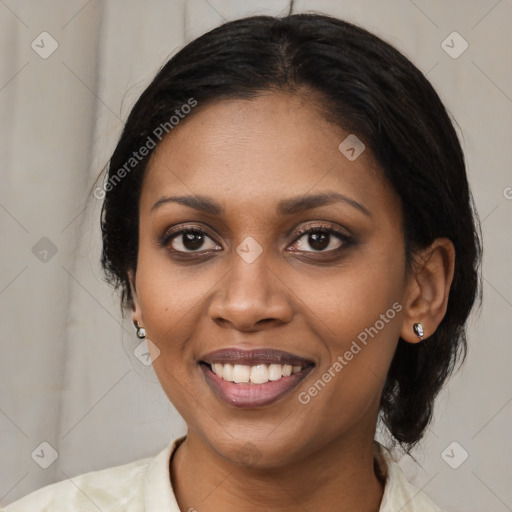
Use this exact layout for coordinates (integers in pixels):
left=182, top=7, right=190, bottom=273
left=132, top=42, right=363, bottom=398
left=400, top=238, right=455, bottom=343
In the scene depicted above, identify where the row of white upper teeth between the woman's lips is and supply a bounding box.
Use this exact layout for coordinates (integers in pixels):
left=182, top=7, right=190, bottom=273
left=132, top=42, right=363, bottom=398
left=211, top=363, right=302, bottom=384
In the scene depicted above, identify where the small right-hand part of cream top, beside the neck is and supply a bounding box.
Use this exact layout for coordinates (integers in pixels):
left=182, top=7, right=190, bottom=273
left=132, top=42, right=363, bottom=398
left=375, top=443, right=442, bottom=512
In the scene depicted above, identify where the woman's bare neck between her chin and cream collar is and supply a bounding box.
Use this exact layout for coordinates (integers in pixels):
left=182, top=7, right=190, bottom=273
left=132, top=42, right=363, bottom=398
left=171, top=430, right=384, bottom=512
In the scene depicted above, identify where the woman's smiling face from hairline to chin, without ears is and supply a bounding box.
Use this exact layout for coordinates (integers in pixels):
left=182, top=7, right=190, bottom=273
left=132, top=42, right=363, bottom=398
left=134, top=93, right=407, bottom=467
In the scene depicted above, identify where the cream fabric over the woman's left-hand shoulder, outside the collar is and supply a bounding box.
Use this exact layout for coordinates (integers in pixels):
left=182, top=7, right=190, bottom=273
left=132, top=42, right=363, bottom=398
left=0, top=447, right=170, bottom=512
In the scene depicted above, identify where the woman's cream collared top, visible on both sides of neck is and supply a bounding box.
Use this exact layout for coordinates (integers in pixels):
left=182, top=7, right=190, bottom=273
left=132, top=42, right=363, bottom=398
left=0, top=436, right=441, bottom=512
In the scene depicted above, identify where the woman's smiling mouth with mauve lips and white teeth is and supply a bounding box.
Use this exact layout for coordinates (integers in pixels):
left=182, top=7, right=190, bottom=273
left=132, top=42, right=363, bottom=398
left=199, top=349, right=315, bottom=409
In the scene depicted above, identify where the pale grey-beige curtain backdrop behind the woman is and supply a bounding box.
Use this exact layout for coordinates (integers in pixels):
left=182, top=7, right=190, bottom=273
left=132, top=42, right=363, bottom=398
left=0, top=0, right=512, bottom=512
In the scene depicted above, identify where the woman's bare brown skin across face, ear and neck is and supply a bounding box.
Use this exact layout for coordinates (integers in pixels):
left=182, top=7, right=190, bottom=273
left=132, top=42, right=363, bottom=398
left=130, top=92, right=455, bottom=512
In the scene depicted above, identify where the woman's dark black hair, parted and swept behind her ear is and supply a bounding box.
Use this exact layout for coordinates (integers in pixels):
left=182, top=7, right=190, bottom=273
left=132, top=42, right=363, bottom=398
left=101, top=14, right=481, bottom=449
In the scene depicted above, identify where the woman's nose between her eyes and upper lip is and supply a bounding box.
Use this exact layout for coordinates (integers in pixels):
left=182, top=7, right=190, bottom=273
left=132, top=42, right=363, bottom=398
left=209, top=248, right=293, bottom=332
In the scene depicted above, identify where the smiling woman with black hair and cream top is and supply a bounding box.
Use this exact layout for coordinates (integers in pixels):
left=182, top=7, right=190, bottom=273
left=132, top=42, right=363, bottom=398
left=5, top=14, right=481, bottom=512
